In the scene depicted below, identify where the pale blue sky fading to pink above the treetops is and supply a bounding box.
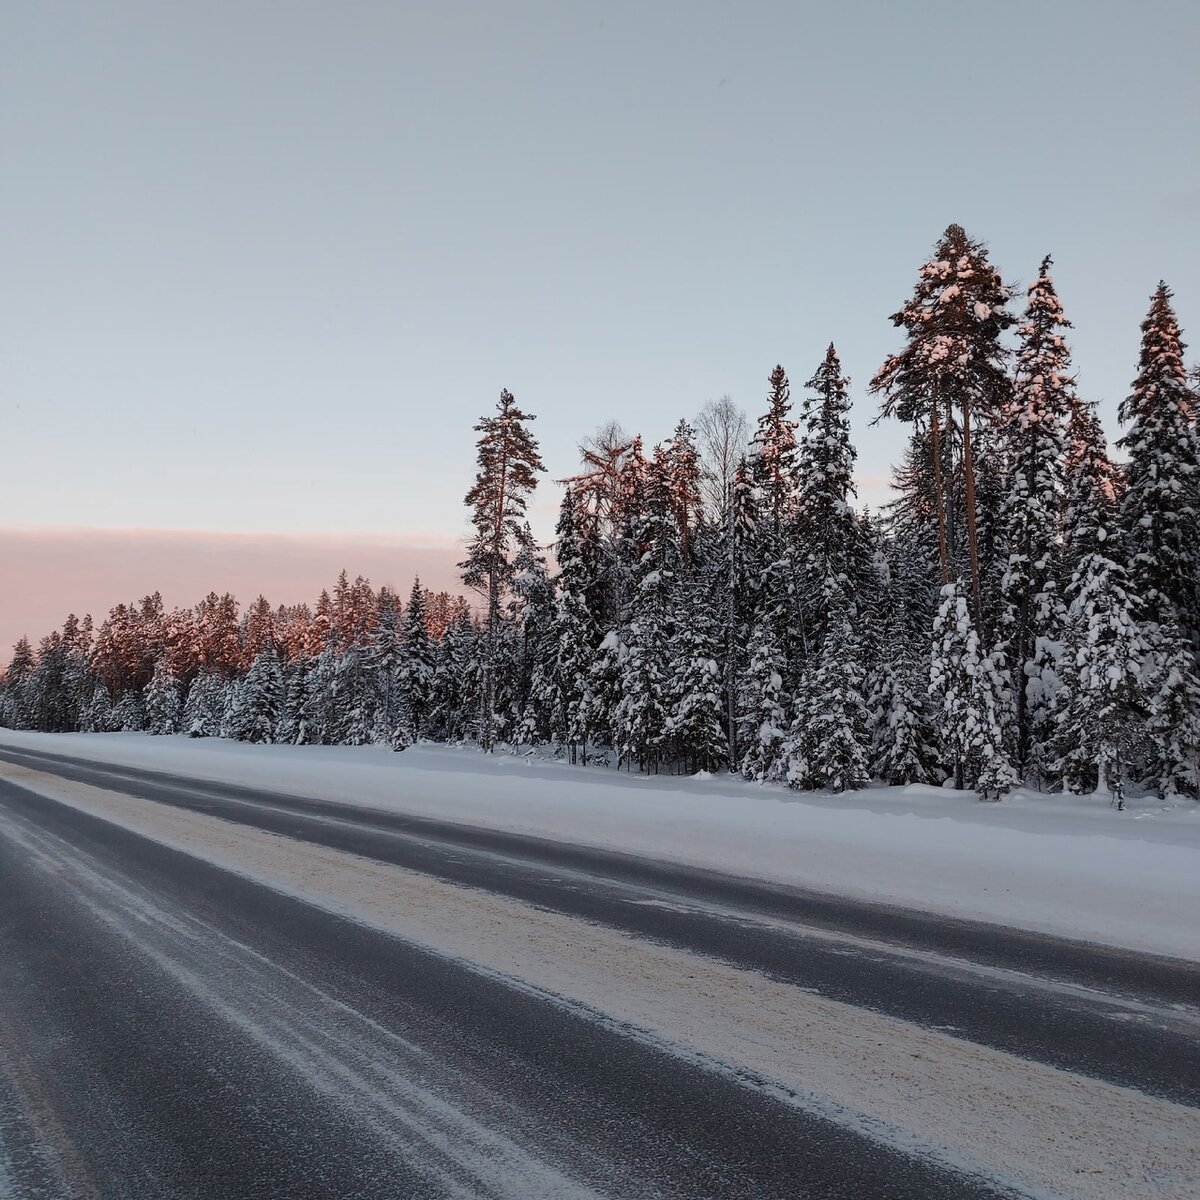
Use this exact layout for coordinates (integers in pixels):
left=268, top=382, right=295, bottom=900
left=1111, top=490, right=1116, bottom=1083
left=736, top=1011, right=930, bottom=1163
left=0, top=0, right=1200, bottom=653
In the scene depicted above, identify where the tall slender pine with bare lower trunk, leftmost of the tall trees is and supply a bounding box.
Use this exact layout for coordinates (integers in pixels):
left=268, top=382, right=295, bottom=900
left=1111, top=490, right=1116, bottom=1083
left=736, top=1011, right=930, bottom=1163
left=460, top=390, right=545, bottom=751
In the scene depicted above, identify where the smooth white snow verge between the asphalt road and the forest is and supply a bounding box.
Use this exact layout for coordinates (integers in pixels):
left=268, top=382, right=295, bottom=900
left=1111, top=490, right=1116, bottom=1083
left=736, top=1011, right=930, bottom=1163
left=7, top=730, right=1200, bottom=960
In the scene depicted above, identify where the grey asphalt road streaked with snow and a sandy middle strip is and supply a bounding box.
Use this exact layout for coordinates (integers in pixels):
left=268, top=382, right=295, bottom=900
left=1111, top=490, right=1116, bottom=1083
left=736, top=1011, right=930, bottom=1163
left=0, top=746, right=1200, bottom=1200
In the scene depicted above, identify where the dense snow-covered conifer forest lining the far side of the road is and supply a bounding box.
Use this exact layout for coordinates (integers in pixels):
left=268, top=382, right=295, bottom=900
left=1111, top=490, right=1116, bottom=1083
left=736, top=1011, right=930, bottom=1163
left=0, top=226, right=1200, bottom=804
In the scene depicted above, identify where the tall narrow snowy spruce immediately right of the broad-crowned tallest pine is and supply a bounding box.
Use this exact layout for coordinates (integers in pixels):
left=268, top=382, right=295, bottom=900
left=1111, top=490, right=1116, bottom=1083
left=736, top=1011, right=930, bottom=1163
left=998, top=254, right=1079, bottom=774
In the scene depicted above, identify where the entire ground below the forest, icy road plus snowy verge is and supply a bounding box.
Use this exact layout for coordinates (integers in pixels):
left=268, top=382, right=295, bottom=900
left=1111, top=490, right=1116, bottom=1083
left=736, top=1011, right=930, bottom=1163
left=0, top=731, right=1200, bottom=1200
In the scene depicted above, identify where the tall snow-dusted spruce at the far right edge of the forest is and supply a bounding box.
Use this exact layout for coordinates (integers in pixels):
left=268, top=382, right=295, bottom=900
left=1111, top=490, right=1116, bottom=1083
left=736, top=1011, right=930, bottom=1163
left=1117, top=283, right=1200, bottom=642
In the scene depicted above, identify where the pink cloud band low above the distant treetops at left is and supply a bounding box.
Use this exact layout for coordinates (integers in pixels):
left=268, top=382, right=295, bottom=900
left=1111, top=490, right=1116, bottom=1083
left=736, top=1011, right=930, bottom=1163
left=0, top=528, right=464, bottom=668
